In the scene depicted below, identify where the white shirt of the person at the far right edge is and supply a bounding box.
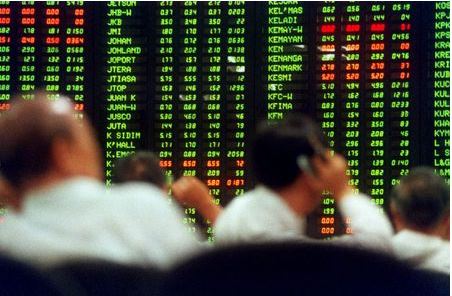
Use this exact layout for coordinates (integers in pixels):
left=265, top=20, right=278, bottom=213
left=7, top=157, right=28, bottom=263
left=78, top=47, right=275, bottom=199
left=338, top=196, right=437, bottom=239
left=392, top=230, right=450, bottom=273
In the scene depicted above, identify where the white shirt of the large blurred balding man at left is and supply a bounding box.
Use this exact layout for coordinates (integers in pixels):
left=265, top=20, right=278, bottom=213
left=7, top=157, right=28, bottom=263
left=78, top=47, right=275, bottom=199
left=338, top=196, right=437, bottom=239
left=0, top=178, right=200, bottom=268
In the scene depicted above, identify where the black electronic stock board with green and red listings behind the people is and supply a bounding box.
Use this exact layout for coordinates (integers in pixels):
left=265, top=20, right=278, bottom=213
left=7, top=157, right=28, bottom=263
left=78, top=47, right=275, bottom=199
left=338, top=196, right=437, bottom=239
left=0, top=1, right=450, bottom=240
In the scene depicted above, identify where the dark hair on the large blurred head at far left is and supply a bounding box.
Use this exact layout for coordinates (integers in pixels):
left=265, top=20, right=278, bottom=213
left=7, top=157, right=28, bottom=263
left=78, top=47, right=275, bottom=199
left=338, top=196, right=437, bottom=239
left=0, top=92, right=72, bottom=186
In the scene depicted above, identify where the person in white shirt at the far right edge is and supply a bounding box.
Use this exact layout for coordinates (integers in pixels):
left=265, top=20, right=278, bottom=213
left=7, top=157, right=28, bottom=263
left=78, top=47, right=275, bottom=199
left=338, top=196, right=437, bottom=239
left=391, top=167, right=450, bottom=273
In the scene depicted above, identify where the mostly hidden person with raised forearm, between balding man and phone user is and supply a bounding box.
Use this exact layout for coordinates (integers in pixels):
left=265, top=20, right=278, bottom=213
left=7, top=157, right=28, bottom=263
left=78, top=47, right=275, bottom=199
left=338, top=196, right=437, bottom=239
left=113, top=151, right=221, bottom=222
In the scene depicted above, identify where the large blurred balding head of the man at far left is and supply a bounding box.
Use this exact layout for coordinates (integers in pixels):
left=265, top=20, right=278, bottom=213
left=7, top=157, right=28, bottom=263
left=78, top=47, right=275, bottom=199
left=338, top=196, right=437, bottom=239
left=0, top=93, right=100, bottom=187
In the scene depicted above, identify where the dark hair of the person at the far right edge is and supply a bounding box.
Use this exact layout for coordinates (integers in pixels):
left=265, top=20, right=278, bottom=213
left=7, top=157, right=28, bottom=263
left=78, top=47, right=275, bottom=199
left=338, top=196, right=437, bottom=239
left=390, top=167, right=450, bottom=229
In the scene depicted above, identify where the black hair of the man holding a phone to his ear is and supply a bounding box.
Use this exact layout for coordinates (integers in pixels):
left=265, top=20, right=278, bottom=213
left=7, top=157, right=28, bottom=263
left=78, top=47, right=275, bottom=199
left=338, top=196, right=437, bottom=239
left=251, top=114, right=327, bottom=189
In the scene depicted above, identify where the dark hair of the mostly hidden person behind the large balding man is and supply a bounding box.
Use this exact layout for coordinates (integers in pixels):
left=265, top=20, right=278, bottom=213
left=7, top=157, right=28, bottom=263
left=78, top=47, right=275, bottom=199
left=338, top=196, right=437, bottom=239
left=112, top=151, right=166, bottom=187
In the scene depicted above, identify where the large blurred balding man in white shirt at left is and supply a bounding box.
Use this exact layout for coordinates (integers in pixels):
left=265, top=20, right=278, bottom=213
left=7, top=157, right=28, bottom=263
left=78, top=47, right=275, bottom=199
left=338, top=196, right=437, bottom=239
left=0, top=93, right=199, bottom=268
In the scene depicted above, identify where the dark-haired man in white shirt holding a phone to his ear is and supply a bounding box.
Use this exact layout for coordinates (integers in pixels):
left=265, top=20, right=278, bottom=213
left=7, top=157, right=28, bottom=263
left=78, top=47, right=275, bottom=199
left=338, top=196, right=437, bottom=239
left=214, top=115, right=392, bottom=251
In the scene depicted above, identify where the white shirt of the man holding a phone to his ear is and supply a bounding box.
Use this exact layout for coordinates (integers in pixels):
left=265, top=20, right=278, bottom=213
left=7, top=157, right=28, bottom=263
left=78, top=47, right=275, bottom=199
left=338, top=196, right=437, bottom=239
left=215, top=186, right=393, bottom=252
